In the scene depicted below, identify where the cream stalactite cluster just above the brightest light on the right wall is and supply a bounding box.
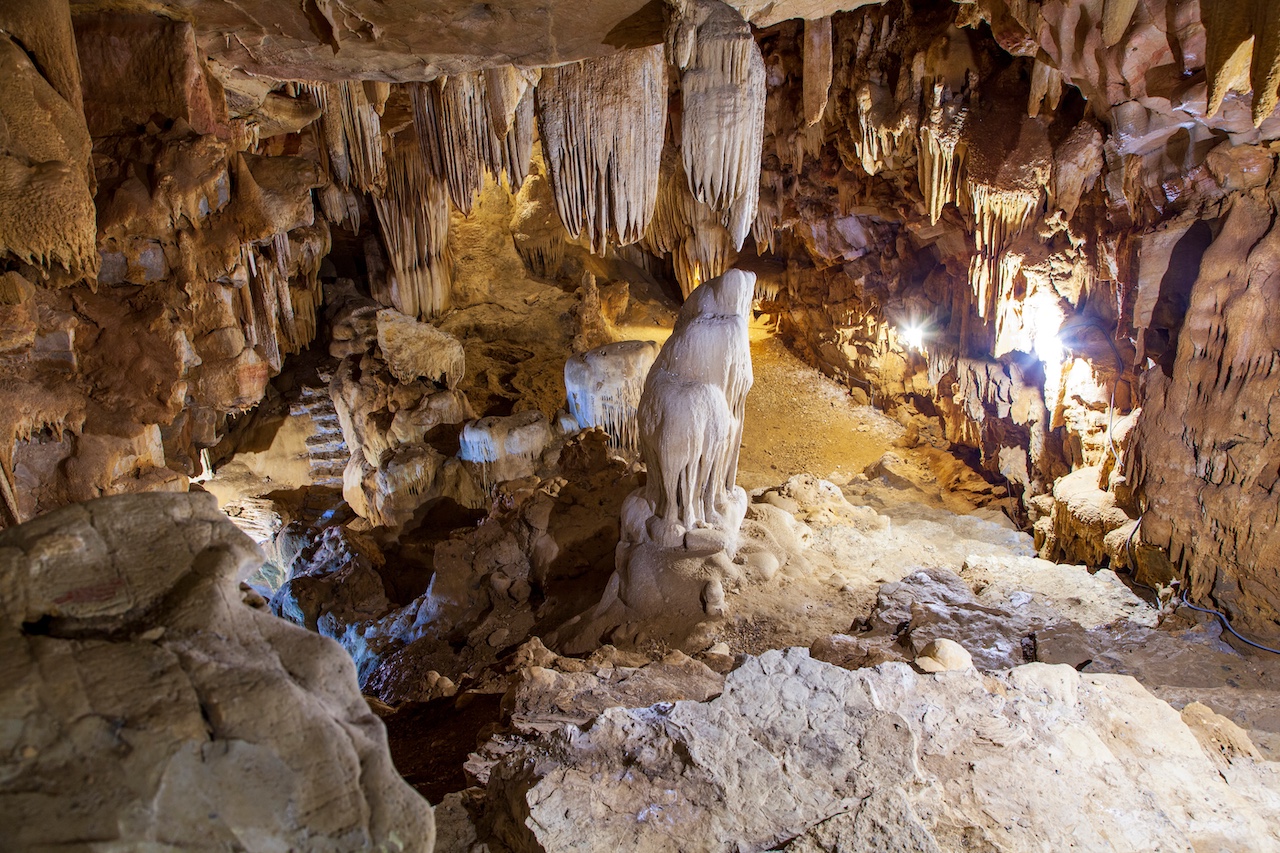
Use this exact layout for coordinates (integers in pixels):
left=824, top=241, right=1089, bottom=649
left=969, top=183, right=1043, bottom=318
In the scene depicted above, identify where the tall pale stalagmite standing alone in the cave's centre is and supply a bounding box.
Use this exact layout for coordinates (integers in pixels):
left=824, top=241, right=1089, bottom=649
left=568, top=270, right=755, bottom=639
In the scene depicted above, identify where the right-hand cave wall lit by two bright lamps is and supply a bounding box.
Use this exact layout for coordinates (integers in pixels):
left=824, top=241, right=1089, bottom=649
left=753, top=0, right=1280, bottom=634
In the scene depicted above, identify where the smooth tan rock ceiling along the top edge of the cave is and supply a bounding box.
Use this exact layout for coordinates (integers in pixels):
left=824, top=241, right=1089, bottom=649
left=70, top=0, right=873, bottom=82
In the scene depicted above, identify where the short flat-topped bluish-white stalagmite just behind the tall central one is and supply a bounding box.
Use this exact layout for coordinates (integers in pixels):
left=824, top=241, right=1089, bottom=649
left=564, top=341, right=658, bottom=456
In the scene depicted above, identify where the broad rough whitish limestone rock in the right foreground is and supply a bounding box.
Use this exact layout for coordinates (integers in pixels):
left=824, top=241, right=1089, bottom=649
left=481, top=649, right=1280, bottom=852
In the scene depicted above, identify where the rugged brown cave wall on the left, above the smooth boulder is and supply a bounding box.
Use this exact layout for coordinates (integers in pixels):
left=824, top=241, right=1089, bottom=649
left=0, top=1, right=329, bottom=524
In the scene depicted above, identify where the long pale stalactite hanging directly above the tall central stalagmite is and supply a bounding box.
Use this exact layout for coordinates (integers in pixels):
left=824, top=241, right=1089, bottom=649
left=672, top=0, right=765, bottom=248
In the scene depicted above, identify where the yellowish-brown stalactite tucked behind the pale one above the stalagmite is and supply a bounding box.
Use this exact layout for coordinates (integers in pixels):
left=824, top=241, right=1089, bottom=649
left=645, top=150, right=737, bottom=297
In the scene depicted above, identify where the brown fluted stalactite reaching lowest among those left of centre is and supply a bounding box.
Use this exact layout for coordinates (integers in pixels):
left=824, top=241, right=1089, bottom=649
left=374, top=140, right=452, bottom=318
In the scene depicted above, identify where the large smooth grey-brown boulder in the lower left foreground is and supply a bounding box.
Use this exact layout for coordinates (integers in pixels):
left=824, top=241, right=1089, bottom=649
left=0, top=494, right=434, bottom=853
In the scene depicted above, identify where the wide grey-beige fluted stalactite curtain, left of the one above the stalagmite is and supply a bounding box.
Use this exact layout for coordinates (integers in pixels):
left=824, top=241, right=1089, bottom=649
left=536, top=46, right=667, bottom=254
